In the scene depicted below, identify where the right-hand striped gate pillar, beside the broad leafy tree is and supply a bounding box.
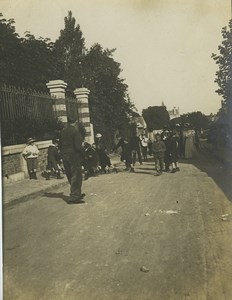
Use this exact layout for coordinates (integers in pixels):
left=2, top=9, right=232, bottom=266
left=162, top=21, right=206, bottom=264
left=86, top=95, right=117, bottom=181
left=74, top=88, right=94, bottom=144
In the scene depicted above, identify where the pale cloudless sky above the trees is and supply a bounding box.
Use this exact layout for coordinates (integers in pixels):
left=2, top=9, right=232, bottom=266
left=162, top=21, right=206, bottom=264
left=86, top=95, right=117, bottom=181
left=0, top=0, right=231, bottom=114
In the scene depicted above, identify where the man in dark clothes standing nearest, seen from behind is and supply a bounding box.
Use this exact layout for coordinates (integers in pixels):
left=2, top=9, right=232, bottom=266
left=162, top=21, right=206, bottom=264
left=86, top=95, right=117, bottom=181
left=60, top=118, right=85, bottom=203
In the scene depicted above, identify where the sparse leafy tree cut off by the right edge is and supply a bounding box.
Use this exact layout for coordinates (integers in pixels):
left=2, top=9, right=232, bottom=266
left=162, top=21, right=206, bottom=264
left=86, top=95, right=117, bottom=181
left=212, top=20, right=232, bottom=126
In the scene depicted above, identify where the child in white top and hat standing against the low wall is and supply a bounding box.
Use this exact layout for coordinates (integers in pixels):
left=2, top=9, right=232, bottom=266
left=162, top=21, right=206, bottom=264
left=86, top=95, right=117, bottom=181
left=22, top=138, right=39, bottom=180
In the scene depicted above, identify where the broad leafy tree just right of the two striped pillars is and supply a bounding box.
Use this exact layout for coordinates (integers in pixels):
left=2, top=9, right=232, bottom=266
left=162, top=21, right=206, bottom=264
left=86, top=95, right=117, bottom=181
left=83, top=44, right=133, bottom=146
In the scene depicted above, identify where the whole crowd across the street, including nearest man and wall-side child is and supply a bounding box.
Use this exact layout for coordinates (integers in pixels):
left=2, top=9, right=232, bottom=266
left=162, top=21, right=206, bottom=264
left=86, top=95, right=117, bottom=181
left=22, top=118, right=197, bottom=203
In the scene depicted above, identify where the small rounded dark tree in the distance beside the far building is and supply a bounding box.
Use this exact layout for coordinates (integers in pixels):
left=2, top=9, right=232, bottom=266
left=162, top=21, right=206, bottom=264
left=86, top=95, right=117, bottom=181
left=142, top=105, right=170, bottom=132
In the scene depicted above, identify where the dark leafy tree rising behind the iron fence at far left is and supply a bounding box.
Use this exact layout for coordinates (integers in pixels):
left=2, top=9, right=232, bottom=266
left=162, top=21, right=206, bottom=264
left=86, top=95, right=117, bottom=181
left=0, top=15, right=55, bottom=91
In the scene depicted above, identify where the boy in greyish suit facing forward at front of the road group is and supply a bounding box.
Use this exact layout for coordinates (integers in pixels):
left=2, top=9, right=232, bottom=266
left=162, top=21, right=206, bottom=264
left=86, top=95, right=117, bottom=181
left=152, top=134, right=166, bottom=176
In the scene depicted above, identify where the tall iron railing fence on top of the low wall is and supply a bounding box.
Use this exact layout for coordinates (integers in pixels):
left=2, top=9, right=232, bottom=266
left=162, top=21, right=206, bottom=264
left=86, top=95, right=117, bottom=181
left=0, top=86, right=61, bottom=146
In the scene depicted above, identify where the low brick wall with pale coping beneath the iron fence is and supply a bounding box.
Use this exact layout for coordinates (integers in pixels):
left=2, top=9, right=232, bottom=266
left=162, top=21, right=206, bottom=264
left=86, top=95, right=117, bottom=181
left=2, top=140, right=52, bottom=183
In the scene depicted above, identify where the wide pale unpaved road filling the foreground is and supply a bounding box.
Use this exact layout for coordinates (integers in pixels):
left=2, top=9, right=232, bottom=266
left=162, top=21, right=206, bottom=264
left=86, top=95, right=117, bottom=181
left=4, top=155, right=232, bottom=300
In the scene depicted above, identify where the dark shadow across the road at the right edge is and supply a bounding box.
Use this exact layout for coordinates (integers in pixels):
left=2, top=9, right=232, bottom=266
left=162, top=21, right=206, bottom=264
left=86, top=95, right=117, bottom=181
left=179, top=152, right=232, bottom=202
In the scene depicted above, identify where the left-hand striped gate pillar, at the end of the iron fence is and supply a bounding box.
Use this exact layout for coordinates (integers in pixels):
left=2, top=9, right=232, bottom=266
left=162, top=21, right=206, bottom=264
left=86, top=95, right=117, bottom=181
left=46, top=80, right=67, bottom=124
